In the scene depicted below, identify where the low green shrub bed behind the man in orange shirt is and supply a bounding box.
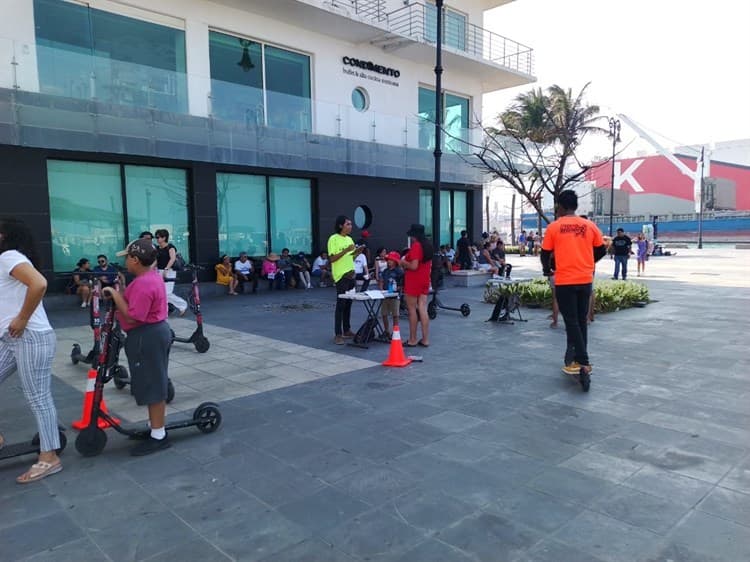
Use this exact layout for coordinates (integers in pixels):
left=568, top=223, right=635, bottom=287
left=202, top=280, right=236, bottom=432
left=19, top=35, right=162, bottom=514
left=484, top=277, right=649, bottom=312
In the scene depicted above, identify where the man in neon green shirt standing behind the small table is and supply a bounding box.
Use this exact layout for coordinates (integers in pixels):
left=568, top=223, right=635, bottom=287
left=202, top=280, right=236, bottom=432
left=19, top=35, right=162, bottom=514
left=328, top=215, right=364, bottom=345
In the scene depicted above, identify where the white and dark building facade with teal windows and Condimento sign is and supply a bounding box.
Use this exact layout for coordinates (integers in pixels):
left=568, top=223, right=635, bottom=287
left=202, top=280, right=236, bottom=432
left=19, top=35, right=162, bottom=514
left=0, top=0, right=534, bottom=275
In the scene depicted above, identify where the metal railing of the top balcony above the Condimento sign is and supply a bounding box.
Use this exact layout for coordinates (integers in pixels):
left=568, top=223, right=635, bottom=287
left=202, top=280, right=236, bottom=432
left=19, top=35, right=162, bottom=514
left=387, top=3, right=534, bottom=75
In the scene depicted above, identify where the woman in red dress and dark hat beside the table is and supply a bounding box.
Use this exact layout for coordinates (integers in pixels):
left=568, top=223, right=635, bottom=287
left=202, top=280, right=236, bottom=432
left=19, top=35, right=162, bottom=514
left=401, top=224, right=435, bottom=347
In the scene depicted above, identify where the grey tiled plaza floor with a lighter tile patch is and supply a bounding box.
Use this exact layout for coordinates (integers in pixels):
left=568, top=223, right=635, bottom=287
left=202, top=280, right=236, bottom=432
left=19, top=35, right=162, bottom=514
left=0, top=250, right=750, bottom=562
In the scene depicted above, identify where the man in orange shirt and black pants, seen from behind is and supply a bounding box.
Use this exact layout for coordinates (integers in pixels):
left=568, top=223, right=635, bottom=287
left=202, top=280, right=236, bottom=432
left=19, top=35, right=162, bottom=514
left=541, top=190, right=606, bottom=390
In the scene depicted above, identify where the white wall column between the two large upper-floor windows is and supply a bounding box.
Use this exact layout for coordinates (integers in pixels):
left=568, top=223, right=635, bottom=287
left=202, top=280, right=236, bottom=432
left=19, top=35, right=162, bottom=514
left=185, top=19, right=211, bottom=117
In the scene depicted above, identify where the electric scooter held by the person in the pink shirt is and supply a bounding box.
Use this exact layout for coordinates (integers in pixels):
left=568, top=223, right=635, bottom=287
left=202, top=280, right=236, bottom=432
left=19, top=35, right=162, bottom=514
left=75, top=274, right=221, bottom=457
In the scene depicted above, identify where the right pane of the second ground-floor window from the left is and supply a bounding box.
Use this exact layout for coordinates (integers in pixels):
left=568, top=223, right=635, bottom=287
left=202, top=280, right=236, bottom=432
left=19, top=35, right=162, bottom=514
left=268, top=177, right=312, bottom=254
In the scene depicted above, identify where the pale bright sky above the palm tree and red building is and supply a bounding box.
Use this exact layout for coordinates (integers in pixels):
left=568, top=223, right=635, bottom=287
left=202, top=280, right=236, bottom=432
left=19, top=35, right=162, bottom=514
left=483, top=0, right=750, bottom=161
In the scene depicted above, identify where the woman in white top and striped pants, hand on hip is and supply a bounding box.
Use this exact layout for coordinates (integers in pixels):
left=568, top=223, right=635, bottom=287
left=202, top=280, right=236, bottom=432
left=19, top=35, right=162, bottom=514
left=0, top=219, right=62, bottom=484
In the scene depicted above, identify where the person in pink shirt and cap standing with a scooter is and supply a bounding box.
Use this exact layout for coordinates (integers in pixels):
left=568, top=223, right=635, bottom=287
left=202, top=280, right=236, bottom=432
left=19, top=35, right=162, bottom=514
left=104, top=239, right=172, bottom=456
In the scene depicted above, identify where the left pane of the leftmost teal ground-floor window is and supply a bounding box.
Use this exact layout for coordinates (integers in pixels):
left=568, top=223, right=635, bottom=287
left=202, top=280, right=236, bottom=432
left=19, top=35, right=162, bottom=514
left=47, top=160, right=127, bottom=271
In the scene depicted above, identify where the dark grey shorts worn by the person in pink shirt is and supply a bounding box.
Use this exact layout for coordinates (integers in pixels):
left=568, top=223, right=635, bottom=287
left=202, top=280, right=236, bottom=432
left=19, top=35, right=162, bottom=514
left=125, top=322, right=172, bottom=406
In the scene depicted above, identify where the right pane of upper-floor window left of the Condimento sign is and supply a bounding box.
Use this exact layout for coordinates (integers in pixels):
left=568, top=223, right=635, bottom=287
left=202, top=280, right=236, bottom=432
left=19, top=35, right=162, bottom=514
left=265, top=46, right=312, bottom=131
